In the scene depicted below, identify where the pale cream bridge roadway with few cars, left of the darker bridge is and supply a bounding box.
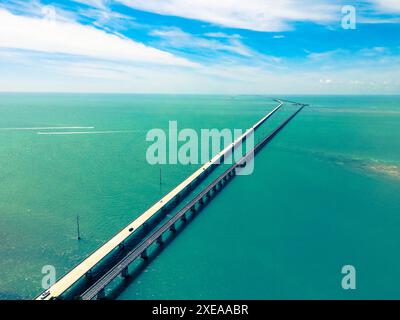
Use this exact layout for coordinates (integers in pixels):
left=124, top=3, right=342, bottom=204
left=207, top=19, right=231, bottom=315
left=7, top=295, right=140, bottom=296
left=35, top=99, right=284, bottom=300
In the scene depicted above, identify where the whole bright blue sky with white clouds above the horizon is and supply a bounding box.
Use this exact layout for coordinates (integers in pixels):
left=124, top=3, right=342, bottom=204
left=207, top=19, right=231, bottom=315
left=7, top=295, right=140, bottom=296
left=0, top=0, right=400, bottom=94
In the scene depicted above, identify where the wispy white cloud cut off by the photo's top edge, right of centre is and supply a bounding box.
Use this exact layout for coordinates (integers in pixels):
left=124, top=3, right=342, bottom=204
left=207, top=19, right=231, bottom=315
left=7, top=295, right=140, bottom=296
left=118, top=0, right=340, bottom=31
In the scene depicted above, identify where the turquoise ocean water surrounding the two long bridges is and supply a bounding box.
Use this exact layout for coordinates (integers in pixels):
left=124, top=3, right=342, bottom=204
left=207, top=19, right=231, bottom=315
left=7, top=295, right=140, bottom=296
left=0, top=94, right=400, bottom=299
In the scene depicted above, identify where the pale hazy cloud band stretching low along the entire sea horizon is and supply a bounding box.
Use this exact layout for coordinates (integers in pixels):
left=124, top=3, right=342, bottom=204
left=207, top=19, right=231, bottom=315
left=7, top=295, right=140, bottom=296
left=0, top=44, right=400, bottom=94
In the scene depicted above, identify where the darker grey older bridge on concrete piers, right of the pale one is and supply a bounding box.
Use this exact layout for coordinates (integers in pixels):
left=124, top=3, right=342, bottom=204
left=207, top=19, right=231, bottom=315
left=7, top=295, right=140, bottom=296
left=80, top=104, right=304, bottom=300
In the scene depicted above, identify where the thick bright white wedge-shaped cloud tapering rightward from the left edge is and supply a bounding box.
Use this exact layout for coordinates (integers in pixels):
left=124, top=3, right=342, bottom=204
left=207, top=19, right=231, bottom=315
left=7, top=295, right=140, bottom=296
left=0, top=8, right=195, bottom=66
